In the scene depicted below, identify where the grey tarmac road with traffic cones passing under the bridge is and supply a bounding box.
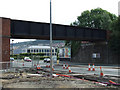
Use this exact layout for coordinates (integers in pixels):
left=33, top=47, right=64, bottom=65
left=12, top=60, right=120, bottom=76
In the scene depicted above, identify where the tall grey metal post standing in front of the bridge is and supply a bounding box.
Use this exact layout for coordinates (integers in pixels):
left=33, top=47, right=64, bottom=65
left=50, top=0, right=53, bottom=77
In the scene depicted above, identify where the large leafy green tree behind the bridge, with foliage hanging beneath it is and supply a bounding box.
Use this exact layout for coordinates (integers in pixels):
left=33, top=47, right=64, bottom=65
left=66, top=8, right=117, bottom=55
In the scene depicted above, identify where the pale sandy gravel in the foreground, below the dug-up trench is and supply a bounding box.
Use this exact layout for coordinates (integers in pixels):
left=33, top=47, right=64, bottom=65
left=1, top=73, right=116, bottom=88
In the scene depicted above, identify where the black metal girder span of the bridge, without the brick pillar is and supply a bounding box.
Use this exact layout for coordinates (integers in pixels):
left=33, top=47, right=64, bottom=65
left=11, top=20, right=107, bottom=41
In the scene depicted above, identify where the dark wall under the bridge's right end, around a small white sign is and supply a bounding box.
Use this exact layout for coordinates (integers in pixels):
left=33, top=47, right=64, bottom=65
left=72, top=43, right=120, bottom=64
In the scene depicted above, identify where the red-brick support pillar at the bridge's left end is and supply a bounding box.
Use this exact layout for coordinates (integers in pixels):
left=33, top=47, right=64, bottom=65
left=0, top=18, right=10, bottom=69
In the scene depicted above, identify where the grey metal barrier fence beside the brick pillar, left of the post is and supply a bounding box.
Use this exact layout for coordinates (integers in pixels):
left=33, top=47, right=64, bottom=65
left=0, top=60, right=54, bottom=72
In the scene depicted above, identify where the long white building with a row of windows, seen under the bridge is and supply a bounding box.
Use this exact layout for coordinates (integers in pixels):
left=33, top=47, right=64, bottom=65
left=22, top=46, right=57, bottom=56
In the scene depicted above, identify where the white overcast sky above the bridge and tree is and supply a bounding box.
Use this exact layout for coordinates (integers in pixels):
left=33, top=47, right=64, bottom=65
left=0, top=0, right=120, bottom=42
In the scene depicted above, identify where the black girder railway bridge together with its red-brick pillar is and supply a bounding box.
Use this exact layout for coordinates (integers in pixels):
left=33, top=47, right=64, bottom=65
left=0, top=17, right=107, bottom=67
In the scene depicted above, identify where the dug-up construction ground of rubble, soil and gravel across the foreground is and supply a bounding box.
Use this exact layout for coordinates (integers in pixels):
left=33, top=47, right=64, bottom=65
left=1, top=69, right=119, bottom=89
